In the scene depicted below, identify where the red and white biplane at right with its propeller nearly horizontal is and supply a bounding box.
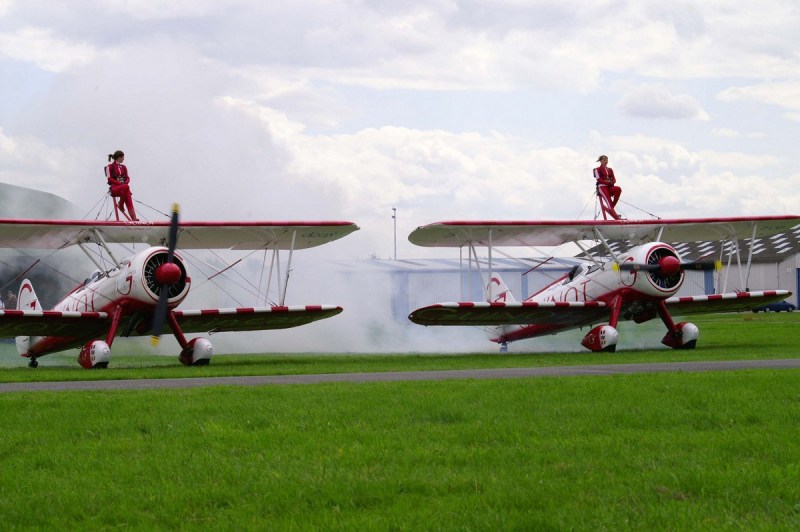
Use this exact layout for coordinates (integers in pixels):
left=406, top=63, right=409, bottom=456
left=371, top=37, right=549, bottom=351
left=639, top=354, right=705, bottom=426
left=409, top=216, right=800, bottom=352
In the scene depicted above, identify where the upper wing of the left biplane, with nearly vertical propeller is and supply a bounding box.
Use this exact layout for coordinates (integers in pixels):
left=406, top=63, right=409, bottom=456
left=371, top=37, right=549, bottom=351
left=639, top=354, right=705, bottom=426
left=0, top=219, right=358, bottom=250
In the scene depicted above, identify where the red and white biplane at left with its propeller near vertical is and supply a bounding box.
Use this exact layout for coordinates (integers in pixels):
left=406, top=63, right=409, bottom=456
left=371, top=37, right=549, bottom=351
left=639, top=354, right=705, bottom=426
left=0, top=205, right=358, bottom=368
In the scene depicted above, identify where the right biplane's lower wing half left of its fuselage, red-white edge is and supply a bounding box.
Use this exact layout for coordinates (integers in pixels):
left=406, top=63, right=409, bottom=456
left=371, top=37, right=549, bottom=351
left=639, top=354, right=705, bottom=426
left=408, top=301, right=608, bottom=325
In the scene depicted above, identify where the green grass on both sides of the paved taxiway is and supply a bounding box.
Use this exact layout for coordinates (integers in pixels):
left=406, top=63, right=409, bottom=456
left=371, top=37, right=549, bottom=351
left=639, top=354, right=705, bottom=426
left=0, top=314, right=800, bottom=530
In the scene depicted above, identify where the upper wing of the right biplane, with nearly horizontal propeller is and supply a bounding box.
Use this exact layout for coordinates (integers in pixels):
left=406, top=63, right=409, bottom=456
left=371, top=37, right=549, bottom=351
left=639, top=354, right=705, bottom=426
left=408, top=216, right=800, bottom=247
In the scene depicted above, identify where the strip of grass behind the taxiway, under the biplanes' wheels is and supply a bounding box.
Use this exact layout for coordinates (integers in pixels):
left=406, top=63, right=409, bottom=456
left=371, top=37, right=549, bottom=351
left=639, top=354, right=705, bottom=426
left=0, top=312, right=800, bottom=382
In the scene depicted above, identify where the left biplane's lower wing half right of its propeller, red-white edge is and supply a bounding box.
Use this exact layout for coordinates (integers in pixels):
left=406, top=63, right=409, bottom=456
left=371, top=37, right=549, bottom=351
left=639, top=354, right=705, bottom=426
left=170, top=305, right=342, bottom=334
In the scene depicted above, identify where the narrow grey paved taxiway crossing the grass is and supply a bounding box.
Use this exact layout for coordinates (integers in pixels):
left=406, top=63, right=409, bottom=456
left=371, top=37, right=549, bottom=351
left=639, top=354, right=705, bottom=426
left=0, top=358, right=800, bottom=393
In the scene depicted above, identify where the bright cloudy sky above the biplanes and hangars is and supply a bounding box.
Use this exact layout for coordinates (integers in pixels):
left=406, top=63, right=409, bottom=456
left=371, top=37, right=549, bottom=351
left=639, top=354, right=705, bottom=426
left=0, top=0, right=800, bottom=258
